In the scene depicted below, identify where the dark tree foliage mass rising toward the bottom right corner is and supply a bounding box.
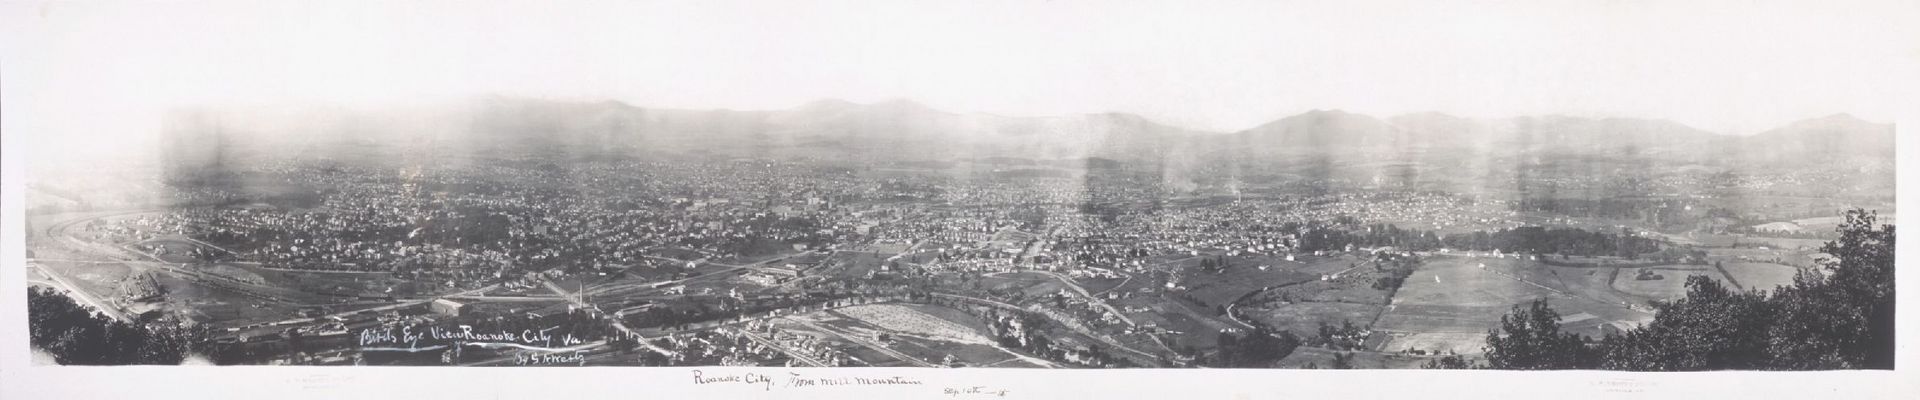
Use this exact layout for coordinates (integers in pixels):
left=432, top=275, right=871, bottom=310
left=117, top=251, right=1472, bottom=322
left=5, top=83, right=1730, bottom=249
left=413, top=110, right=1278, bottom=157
left=1427, top=210, right=1893, bottom=371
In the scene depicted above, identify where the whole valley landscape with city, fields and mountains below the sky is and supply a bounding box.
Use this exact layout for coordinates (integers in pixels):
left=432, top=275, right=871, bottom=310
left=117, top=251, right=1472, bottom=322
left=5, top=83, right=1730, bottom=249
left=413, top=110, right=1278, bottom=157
left=25, top=96, right=1895, bottom=371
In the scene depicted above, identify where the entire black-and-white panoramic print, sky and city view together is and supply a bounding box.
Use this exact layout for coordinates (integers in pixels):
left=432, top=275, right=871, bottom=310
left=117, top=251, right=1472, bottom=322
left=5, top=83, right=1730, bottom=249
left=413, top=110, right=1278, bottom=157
left=10, top=4, right=1899, bottom=381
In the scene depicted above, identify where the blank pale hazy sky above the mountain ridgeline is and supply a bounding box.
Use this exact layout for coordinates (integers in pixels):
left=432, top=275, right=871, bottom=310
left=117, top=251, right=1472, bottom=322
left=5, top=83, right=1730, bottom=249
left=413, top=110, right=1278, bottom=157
left=0, top=0, right=1920, bottom=150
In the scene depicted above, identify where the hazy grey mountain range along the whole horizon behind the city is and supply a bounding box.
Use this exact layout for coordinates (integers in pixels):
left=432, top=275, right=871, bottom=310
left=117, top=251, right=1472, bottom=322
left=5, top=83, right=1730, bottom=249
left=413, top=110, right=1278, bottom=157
left=165, top=96, right=1893, bottom=171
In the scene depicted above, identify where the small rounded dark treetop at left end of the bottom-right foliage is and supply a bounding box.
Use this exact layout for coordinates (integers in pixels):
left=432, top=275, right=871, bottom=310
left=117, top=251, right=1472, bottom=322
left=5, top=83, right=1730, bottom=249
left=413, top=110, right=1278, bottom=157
left=1486, top=300, right=1599, bottom=369
